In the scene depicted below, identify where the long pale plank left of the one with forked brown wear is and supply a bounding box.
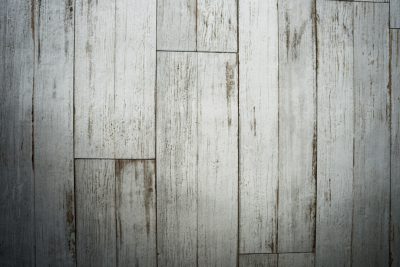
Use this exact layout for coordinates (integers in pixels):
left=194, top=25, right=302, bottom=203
left=239, top=0, right=278, bottom=253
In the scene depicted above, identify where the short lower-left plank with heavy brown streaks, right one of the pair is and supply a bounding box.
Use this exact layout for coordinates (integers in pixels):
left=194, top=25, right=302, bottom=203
left=115, top=160, right=157, bottom=266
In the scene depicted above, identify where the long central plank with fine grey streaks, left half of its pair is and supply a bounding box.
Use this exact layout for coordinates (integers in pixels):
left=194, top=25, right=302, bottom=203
left=156, top=52, right=198, bottom=266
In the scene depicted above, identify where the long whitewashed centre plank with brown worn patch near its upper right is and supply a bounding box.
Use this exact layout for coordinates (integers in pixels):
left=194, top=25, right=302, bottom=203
left=197, top=53, right=238, bottom=266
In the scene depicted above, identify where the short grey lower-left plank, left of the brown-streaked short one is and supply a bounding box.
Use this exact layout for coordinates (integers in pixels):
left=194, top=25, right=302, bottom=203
left=75, top=160, right=116, bottom=266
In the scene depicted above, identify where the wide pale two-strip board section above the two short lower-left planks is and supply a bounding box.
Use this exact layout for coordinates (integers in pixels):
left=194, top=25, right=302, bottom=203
left=75, top=0, right=156, bottom=158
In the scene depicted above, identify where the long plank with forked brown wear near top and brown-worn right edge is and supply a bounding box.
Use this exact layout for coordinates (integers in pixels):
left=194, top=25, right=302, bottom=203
left=278, top=0, right=316, bottom=252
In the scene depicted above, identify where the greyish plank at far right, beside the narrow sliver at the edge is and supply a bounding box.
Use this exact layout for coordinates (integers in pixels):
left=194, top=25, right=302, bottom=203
left=352, top=3, right=390, bottom=266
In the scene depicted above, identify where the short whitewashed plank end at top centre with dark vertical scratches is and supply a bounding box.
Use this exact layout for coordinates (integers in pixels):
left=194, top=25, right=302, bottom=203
left=196, top=0, right=237, bottom=52
